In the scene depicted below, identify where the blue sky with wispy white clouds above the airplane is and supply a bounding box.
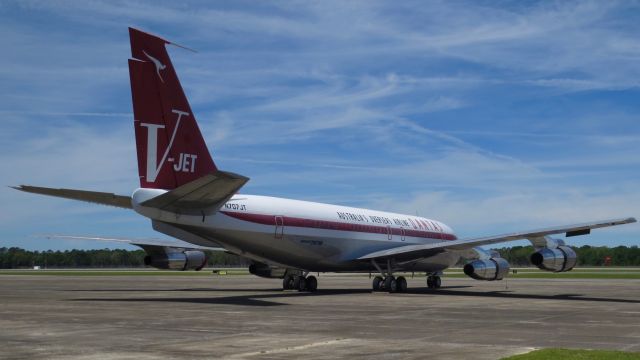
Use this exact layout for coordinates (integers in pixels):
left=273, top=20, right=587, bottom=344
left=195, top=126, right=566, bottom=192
left=0, top=1, right=640, bottom=249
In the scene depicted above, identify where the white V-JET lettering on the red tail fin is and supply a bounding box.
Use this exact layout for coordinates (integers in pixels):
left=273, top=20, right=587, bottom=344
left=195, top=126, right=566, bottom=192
left=140, top=109, right=198, bottom=182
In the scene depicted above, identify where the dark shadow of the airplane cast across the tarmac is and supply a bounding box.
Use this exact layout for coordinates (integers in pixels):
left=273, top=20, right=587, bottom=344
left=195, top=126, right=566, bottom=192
left=68, top=286, right=640, bottom=306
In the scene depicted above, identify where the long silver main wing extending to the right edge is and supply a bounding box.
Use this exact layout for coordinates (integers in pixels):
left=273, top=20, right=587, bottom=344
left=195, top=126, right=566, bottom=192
left=357, top=217, right=636, bottom=260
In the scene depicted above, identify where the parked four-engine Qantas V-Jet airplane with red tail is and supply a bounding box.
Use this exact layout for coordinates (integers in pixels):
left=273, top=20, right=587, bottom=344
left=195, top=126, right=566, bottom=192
left=14, top=28, right=636, bottom=292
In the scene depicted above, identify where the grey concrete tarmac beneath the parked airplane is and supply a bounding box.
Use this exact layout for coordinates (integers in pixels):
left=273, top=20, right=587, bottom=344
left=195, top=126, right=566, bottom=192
left=0, top=274, right=640, bottom=360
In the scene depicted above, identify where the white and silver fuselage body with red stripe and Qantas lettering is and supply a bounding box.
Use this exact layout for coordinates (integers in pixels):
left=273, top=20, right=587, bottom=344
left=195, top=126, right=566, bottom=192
left=132, top=188, right=459, bottom=271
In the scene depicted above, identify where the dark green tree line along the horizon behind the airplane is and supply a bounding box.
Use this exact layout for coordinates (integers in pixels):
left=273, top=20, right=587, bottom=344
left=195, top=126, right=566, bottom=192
left=0, top=245, right=640, bottom=269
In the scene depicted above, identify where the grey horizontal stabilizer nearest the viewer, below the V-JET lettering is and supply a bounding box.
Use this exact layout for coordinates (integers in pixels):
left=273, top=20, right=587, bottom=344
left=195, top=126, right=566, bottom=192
left=141, top=170, right=249, bottom=215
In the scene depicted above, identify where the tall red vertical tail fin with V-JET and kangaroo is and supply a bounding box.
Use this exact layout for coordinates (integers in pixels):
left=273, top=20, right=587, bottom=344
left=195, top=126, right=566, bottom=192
left=129, top=28, right=216, bottom=190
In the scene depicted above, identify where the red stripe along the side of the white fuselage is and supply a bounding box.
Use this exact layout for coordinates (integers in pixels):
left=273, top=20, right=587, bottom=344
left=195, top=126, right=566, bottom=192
left=220, top=211, right=457, bottom=240
